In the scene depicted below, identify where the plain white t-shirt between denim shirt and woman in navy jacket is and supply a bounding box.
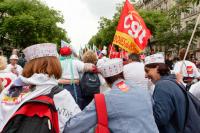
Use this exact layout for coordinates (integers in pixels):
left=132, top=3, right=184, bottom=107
left=123, top=62, right=148, bottom=89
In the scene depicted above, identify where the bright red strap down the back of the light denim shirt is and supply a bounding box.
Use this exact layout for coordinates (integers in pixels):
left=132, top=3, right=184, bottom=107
left=94, top=94, right=110, bottom=133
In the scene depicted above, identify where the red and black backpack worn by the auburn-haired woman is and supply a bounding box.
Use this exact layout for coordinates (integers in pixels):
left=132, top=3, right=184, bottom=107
left=2, top=86, right=62, bottom=133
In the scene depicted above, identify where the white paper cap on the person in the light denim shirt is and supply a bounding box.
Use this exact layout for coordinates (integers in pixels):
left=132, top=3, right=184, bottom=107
left=97, top=58, right=123, bottom=77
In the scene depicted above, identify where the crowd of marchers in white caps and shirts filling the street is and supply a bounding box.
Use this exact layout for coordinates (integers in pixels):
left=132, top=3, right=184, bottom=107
left=0, top=43, right=200, bottom=133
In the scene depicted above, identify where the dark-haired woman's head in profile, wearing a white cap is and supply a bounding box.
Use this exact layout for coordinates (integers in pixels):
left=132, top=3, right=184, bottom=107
left=144, top=54, right=170, bottom=83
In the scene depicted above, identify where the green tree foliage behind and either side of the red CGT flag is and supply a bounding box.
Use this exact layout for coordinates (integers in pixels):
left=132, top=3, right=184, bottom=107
left=89, top=0, right=200, bottom=50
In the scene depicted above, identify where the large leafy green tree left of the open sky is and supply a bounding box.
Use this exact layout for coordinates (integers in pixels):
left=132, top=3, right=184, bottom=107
left=0, top=0, right=70, bottom=48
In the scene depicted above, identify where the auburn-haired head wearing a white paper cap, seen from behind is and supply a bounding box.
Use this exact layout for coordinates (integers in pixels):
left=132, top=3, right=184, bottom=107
left=22, top=43, right=62, bottom=79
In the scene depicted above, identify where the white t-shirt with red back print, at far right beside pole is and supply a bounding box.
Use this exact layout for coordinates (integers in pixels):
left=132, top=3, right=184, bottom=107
left=173, top=60, right=200, bottom=77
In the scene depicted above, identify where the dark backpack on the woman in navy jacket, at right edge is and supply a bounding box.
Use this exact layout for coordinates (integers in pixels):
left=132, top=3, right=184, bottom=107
left=170, top=80, right=200, bottom=133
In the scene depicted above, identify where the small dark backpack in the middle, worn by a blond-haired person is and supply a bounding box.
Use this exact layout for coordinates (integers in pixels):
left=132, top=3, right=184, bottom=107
left=80, top=72, right=100, bottom=97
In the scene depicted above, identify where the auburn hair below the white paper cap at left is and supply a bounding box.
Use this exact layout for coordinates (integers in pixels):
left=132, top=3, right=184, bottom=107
left=22, top=56, right=62, bottom=79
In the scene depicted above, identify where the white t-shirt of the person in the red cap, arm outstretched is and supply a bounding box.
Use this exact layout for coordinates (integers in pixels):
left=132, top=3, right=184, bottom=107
left=60, top=59, right=85, bottom=79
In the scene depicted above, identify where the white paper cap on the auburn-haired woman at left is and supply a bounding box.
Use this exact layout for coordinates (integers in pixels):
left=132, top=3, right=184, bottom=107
left=23, top=43, right=58, bottom=61
